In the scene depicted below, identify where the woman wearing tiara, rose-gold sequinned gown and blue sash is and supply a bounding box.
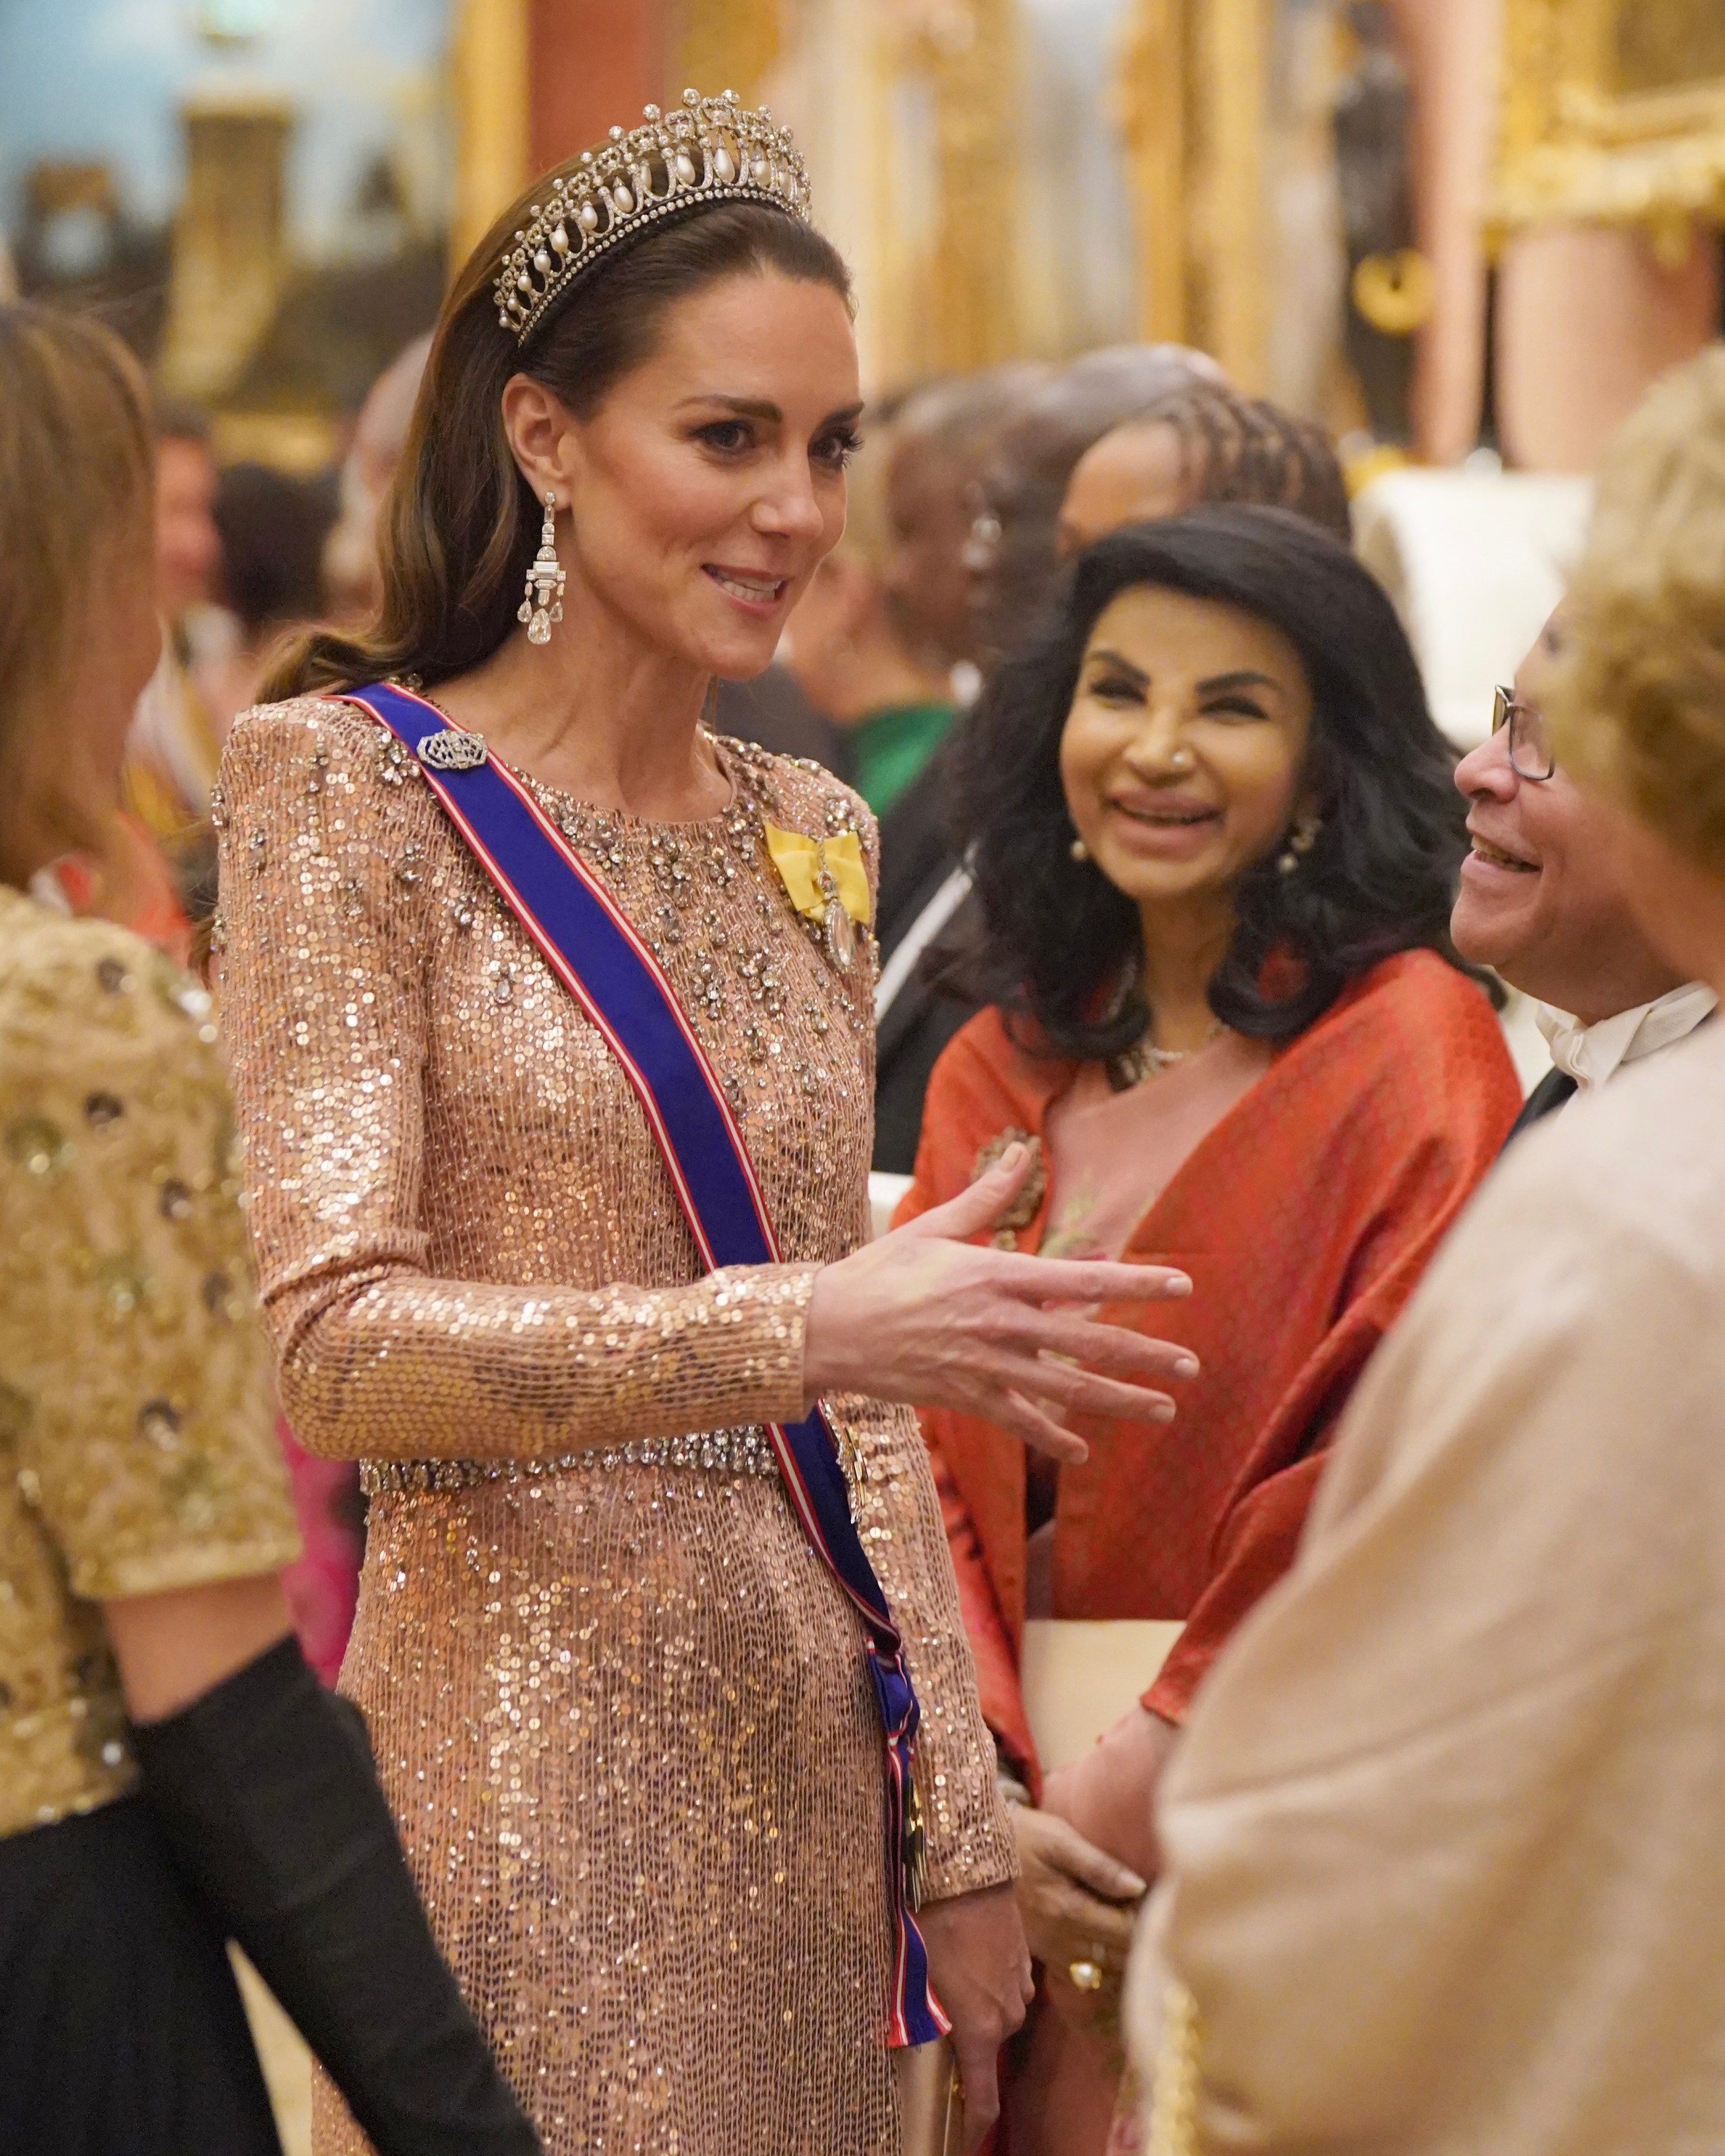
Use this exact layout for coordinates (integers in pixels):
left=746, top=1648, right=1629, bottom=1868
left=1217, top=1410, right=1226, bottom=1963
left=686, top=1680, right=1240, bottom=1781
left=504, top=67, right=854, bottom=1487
left=216, top=93, right=1184, bottom=2156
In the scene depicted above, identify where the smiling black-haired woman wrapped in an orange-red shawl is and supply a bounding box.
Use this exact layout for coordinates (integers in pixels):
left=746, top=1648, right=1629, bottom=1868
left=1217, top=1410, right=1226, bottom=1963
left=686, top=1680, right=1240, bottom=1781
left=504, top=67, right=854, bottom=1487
left=902, top=507, right=1520, bottom=2156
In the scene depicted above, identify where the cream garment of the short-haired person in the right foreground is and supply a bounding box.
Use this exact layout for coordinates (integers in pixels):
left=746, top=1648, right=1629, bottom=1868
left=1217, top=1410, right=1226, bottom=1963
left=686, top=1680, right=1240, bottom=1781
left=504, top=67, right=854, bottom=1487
left=1130, top=1026, right=1725, bottom=2156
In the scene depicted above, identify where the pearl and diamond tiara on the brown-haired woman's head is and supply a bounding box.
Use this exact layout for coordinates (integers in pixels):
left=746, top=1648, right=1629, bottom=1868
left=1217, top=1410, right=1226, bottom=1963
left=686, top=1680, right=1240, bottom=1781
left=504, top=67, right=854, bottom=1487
left=494, top=90, right=809, bottom=343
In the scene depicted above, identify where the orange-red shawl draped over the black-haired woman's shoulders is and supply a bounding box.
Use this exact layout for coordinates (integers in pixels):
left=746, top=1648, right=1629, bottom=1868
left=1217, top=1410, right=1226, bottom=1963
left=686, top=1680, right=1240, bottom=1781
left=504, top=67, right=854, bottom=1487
left=899, top=951, right=1520, bottom=1781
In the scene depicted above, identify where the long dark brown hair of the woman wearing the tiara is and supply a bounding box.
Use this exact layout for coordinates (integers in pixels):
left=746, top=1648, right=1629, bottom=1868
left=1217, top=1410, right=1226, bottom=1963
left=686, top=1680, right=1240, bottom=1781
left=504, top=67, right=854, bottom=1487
left=263, top=184, right=850, bottom=698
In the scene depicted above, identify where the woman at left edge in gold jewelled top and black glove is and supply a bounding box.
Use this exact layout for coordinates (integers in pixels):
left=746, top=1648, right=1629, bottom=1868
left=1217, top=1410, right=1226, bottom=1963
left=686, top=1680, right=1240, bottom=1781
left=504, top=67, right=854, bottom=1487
left=0, top=304, right=537, bottom=2156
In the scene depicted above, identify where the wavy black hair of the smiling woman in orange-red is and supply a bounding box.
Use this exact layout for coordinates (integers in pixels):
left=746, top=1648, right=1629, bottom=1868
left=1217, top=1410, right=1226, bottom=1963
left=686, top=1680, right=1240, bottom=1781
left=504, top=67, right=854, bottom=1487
left=953, top=502, right=1488, bottom=1061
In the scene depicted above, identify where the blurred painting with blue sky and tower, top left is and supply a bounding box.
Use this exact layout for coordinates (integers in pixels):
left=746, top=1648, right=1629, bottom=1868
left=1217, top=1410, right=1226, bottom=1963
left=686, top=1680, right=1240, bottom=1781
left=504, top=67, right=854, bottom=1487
left=0, top=0, right=451, bottom=466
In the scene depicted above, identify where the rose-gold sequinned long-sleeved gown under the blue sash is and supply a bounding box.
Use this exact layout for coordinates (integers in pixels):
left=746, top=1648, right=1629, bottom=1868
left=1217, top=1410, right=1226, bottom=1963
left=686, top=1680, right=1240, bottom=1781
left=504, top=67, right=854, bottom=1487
left=218, top=698, right=1013, bottom=2156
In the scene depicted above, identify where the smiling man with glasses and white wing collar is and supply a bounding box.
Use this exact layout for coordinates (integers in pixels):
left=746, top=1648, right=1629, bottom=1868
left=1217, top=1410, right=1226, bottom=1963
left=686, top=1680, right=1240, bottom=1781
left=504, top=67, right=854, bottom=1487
left=1449, top=608, right=1716, bottom=1136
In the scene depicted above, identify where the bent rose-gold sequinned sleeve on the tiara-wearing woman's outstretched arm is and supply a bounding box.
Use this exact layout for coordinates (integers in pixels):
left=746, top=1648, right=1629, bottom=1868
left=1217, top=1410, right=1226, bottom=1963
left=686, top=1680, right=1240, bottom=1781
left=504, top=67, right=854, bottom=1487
left=220, top=701, right=815, bottom=1460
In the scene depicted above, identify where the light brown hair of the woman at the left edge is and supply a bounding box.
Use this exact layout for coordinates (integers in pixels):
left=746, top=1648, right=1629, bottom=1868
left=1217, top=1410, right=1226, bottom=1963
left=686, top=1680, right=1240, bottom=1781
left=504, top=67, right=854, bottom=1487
left=0, top=300, right=155, bottom=884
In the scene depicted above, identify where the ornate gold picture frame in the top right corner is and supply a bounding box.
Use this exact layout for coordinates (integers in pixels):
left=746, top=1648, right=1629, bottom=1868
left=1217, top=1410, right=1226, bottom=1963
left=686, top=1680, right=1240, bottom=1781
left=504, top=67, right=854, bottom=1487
left=1486, top=0, right=1725, bottom=261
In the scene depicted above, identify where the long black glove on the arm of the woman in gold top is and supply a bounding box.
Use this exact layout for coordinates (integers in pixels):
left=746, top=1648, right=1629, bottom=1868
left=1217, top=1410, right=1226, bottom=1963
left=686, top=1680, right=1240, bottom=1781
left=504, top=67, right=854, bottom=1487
left=131, top=1638, right=541, bottom=2156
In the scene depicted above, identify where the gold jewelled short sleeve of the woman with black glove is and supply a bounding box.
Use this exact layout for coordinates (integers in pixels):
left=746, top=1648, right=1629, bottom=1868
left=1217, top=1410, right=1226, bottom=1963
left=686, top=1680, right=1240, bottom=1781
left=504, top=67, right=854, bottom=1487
left=0, top=919, right=300, bottom=1600
